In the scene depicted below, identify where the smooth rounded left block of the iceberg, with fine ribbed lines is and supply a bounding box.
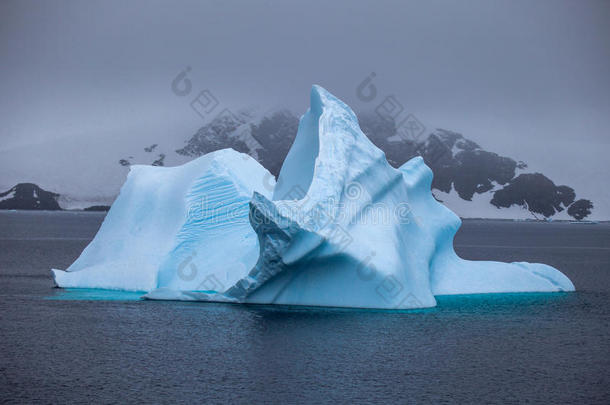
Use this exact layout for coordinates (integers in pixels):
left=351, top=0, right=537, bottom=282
left=53, top=149, right=275, bottom=290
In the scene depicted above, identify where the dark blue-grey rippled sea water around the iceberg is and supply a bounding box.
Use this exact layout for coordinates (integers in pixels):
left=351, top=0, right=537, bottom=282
left=0, top=212, right=610, bottom=404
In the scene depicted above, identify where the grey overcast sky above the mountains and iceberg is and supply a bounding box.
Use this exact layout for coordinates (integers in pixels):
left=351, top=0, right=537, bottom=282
left=0, top=0, right=610, bottom=212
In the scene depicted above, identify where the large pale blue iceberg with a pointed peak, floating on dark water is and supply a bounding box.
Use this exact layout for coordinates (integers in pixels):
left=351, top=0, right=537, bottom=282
left=53, top=86, right=574, bottom=308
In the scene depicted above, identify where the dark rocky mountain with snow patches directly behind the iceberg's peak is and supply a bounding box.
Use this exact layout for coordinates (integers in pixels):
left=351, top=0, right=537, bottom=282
left=156, top=110, right=593, bottom=219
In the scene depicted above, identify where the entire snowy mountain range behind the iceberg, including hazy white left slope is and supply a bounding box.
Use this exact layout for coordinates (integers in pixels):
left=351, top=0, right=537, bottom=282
left=0, top=109, right=592, bottom=219
